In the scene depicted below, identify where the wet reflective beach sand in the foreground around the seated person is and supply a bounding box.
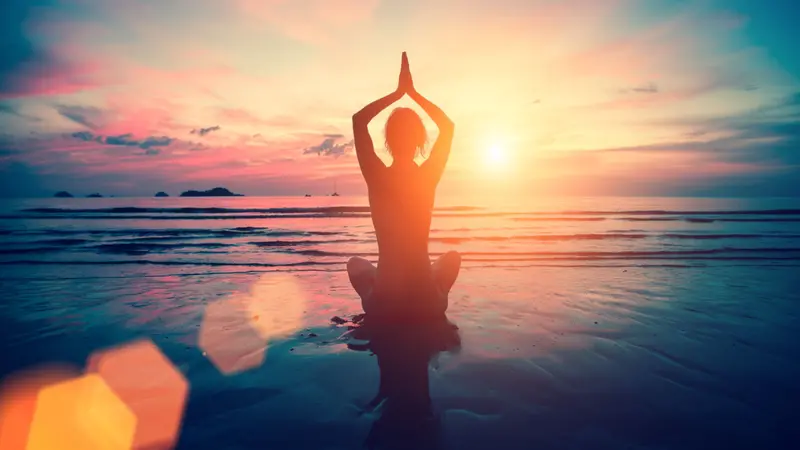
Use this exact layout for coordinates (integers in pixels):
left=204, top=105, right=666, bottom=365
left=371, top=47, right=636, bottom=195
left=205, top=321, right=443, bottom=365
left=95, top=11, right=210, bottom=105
left=0, top=262, right=800, bottom=450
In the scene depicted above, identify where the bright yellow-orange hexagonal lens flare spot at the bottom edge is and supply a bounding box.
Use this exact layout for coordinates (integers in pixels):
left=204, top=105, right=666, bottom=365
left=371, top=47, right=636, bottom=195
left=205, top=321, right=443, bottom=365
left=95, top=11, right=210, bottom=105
left=25, top=374, right=136, bottom=450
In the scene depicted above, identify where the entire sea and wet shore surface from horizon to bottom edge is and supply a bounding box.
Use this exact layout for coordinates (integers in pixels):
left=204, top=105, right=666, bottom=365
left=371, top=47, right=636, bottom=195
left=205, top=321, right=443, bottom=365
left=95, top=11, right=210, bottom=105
left=0, top=197, right=800, bottom=449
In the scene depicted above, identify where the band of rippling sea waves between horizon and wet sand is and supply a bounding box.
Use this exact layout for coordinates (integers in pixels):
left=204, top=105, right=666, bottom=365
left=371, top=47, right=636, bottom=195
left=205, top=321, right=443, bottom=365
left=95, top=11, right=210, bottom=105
left=0, top=197, right=800, bottom=269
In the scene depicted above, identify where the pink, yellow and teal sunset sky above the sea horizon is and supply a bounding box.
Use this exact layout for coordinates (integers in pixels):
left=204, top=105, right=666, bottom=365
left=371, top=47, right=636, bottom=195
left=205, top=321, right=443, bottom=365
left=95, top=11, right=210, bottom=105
left=0, top=0, right=800, bottom=197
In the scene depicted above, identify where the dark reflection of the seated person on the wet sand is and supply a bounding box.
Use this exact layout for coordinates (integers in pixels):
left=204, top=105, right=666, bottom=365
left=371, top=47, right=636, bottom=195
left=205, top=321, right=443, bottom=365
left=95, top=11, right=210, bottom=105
left=348, top=316, right=461, bottom=450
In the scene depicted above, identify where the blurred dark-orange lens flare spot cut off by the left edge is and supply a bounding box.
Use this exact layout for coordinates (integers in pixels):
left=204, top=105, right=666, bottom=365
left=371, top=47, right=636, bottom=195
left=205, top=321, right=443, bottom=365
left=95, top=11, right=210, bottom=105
left=0, top=364, right=80, bottom=450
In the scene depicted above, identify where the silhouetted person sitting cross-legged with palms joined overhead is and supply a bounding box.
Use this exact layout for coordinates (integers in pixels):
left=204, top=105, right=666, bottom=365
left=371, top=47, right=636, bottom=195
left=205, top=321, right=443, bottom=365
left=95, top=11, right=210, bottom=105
left=347, top=52, right=461, bottom=319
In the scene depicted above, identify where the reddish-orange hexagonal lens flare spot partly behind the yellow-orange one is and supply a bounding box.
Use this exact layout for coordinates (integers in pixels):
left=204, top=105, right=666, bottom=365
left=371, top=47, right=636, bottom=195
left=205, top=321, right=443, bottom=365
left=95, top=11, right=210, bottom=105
left=87, top=340, right=189, bottom=450
